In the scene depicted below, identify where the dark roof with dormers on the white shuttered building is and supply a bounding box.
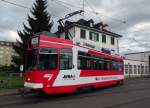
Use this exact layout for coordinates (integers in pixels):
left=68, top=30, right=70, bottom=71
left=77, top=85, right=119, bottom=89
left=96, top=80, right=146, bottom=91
left=57, top=19, right=122, bottom=38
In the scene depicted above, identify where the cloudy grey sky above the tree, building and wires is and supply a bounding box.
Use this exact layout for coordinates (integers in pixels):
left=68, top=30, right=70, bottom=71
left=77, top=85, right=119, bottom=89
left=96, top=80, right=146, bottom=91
left=0, top=0, right=150, bottom=51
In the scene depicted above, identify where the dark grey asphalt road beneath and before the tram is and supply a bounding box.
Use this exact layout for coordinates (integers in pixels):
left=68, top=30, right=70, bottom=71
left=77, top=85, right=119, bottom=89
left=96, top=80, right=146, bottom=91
left=0, top=78, right=150, bottom=108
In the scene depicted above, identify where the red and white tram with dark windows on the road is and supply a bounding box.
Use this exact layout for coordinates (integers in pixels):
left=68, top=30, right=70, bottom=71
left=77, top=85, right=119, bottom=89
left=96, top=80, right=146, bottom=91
left=24, top=35, right=124, bottom=94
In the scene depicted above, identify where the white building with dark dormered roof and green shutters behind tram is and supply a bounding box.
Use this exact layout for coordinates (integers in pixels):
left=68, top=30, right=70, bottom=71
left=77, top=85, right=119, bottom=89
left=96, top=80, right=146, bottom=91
left=59, top=19, right=122, bottom=54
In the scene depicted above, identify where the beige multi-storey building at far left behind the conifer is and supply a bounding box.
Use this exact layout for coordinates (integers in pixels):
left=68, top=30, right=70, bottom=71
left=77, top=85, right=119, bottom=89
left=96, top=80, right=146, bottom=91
left=0, top=41, right=15, bottom=66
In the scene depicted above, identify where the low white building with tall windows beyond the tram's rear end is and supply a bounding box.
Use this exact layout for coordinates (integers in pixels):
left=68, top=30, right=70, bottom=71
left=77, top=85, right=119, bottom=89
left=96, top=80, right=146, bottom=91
left=124, top=51, right=150, bottom=77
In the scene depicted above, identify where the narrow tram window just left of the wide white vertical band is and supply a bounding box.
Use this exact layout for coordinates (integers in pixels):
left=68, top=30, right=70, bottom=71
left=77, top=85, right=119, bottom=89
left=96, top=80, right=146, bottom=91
left=60, top=49, right=73, bottom=70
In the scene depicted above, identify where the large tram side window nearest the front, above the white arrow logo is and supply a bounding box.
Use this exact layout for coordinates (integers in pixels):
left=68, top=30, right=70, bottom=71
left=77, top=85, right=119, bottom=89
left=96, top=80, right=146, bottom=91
left=39, top=48, right=58, bottom=70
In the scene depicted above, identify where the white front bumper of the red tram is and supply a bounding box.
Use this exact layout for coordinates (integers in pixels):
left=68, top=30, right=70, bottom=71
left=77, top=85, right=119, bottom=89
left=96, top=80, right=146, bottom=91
left=24, top=82, right=44, bottom=89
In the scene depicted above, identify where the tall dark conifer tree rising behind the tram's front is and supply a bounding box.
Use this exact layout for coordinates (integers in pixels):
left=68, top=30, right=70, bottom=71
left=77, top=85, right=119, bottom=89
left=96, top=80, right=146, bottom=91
left=13, top=0, right=53, bottom=70
